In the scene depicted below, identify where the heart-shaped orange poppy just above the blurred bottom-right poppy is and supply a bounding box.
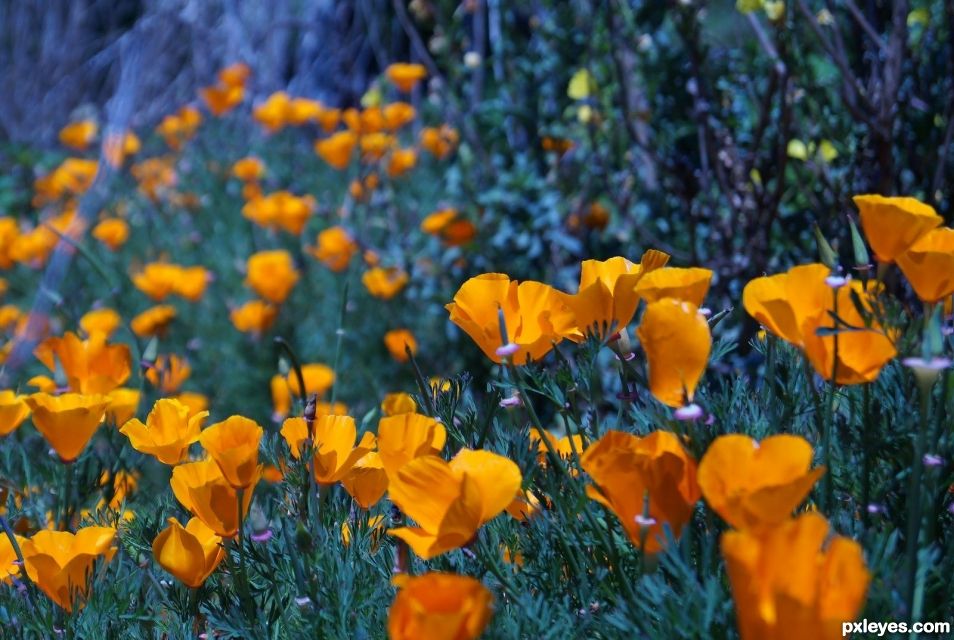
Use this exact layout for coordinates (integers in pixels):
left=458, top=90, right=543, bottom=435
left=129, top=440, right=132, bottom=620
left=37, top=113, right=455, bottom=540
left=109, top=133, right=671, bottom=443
left=699, top=434, right=825, bottom=529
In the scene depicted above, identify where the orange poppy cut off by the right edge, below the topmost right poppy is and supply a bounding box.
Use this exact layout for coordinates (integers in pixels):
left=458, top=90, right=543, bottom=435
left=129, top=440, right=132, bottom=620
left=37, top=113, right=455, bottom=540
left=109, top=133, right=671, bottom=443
left=896, top=227, right=954, bottom=303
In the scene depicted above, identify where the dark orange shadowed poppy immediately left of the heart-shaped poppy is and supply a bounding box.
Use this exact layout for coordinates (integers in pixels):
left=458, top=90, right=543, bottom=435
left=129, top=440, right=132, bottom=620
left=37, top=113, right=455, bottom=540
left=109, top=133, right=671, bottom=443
left=580, top=431, right=699, bottom=553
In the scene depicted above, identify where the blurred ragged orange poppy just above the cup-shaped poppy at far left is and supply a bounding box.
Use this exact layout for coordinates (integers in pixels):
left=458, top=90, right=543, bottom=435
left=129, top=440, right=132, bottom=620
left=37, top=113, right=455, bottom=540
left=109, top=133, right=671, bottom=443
left=33, top=332, right=132, bottom=393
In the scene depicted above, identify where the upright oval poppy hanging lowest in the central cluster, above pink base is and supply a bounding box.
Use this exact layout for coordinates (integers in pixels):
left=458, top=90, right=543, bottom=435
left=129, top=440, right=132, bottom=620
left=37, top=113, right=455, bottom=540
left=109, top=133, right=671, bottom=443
left=637, top=298, right=712, bottom=407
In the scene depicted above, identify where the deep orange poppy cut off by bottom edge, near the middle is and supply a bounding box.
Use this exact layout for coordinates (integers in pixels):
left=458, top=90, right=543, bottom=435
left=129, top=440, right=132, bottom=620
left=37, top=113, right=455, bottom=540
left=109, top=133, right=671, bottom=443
left=388, top=572, right=493, bottom=640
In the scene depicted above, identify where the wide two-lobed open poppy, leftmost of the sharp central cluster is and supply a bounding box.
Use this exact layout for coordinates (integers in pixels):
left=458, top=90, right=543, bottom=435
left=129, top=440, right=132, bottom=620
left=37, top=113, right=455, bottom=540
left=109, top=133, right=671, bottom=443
left=445, top=273, right=580, bottom=364
